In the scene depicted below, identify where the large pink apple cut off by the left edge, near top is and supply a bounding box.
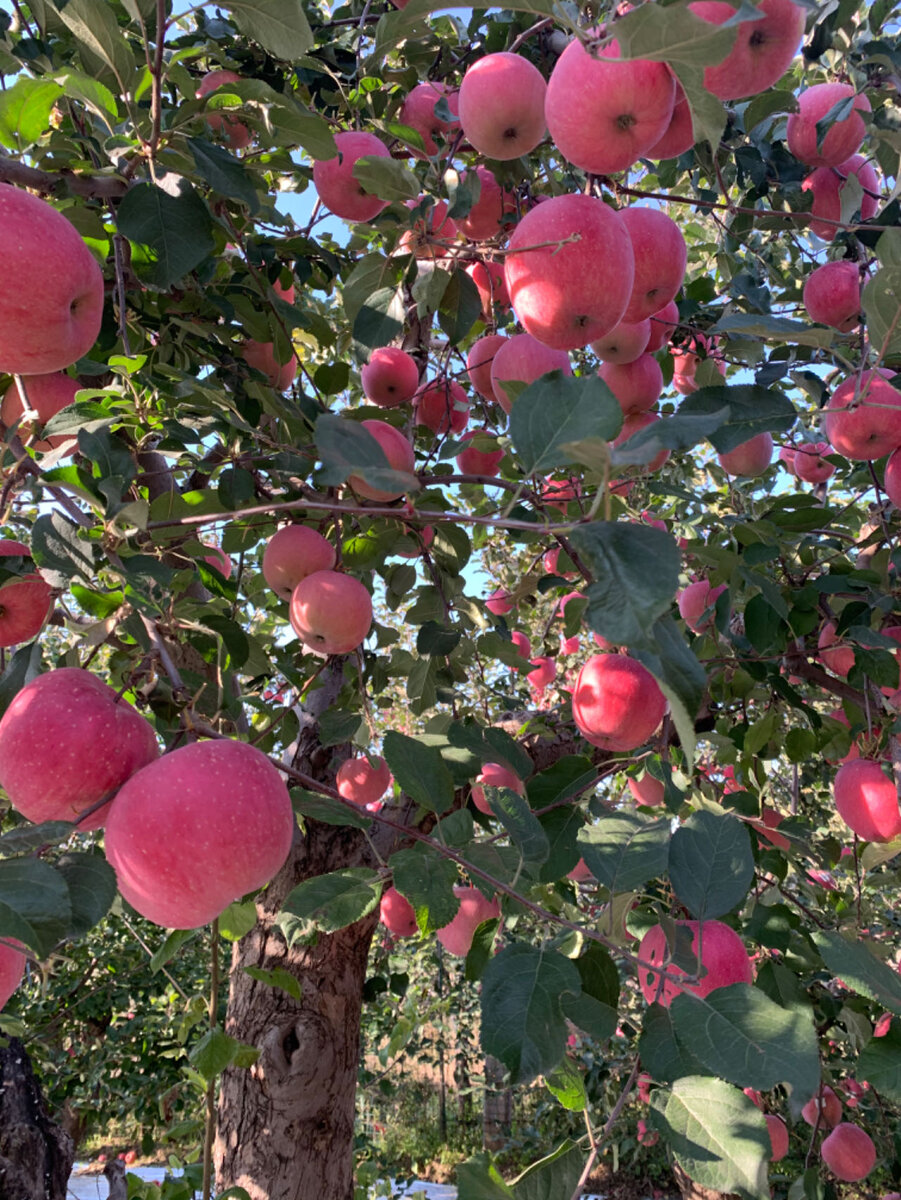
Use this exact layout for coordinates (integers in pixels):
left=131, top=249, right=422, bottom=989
left=0, top=184, right=103, bottom=376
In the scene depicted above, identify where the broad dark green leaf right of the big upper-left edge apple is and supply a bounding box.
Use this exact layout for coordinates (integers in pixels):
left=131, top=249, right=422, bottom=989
left=116, top=177, right=215, bottom=292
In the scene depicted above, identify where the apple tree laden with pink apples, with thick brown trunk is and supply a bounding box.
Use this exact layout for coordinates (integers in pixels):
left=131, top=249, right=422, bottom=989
left=0, top=0, right=901, bottom=1200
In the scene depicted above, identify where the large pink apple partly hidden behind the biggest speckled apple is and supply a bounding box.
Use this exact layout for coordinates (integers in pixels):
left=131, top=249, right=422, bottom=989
left=0, top=667, right=160, bottom=829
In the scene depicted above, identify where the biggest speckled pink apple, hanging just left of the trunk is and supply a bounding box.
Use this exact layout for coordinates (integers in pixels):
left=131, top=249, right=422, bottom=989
left=104, top=738, right=295, bottom=929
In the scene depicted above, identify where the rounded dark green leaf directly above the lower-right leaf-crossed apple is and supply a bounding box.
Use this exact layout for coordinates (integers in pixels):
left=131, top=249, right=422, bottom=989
left=669, top=809, right=755, bottom=920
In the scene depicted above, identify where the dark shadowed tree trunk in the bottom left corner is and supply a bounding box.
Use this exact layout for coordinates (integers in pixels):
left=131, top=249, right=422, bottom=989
left=0, top=1038, right=76, bottom=1200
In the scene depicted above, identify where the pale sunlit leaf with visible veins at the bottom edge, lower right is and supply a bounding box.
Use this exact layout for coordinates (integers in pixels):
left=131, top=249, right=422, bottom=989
left=650, top=1075, right=771, bottom=1200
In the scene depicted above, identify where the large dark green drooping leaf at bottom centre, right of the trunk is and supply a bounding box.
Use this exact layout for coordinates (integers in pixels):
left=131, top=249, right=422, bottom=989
left=481, top=943, right=582, bottom=1084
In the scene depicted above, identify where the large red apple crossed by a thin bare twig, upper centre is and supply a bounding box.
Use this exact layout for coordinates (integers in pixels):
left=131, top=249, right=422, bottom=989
left=504, top=196, right=638, bottom=350
